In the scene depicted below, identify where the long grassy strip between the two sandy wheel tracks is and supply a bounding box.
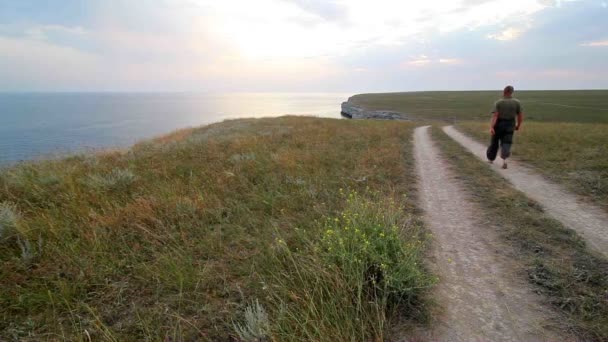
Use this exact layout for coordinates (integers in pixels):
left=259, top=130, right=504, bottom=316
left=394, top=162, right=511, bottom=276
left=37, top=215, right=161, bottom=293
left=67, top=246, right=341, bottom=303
left=433, top=128, right=608, bottom=341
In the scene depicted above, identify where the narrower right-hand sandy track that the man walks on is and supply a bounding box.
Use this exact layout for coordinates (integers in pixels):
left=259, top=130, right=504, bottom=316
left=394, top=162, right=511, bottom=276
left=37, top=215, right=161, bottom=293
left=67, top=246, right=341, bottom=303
left=443, top=126, right=608, bottom=256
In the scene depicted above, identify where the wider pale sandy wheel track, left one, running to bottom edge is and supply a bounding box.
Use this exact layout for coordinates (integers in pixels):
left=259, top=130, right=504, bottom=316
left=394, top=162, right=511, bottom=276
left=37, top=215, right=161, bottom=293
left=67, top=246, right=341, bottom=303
left=414, top=127, right=565, bottom=341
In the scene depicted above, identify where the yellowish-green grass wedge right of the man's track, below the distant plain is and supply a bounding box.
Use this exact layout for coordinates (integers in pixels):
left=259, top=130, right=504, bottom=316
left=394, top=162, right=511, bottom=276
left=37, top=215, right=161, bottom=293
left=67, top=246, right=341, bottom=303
left=457, top=122, right=608, bottom=211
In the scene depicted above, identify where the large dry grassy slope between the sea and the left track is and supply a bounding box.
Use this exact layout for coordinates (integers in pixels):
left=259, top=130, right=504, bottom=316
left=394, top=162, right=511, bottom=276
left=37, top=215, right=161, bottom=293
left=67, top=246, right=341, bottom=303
left=0, top=117, right=434, bottom=341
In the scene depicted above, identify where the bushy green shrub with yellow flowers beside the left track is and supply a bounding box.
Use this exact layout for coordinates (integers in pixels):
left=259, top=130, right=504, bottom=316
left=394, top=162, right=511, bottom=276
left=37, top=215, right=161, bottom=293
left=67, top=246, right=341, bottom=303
left=321, top=193, right=424, bottom=305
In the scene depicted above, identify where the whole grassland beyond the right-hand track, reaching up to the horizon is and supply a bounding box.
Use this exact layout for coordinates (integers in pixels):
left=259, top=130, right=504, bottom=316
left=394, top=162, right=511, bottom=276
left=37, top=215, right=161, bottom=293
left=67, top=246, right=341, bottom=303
left=353, top=90, right=608, bottom=210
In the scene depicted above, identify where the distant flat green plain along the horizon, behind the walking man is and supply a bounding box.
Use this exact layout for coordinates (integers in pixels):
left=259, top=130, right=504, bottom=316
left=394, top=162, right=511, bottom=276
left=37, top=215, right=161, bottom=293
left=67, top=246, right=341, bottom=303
left=351, top=90, right=608, bottom=123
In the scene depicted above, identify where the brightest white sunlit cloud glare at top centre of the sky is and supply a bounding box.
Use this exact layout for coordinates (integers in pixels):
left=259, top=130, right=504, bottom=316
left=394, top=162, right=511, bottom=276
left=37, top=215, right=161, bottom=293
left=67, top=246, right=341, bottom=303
left=197, top=0, right=546, bottom=59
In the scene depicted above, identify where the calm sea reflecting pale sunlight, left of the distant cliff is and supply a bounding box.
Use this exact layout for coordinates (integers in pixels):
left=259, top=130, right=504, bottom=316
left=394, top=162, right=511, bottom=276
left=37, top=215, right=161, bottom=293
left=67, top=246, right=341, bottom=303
left=0, top=93, right=349, bottom=164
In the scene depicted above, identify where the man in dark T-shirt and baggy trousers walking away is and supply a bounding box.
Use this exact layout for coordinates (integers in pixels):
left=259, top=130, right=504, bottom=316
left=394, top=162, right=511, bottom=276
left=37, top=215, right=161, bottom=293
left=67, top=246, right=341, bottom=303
left=486, top=86, right=524, bottom=169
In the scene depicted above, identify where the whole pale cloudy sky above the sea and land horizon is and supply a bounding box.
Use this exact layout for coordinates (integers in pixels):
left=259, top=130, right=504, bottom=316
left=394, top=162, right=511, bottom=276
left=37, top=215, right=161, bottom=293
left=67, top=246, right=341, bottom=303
left=0, top=0, right=608, bottom=92
